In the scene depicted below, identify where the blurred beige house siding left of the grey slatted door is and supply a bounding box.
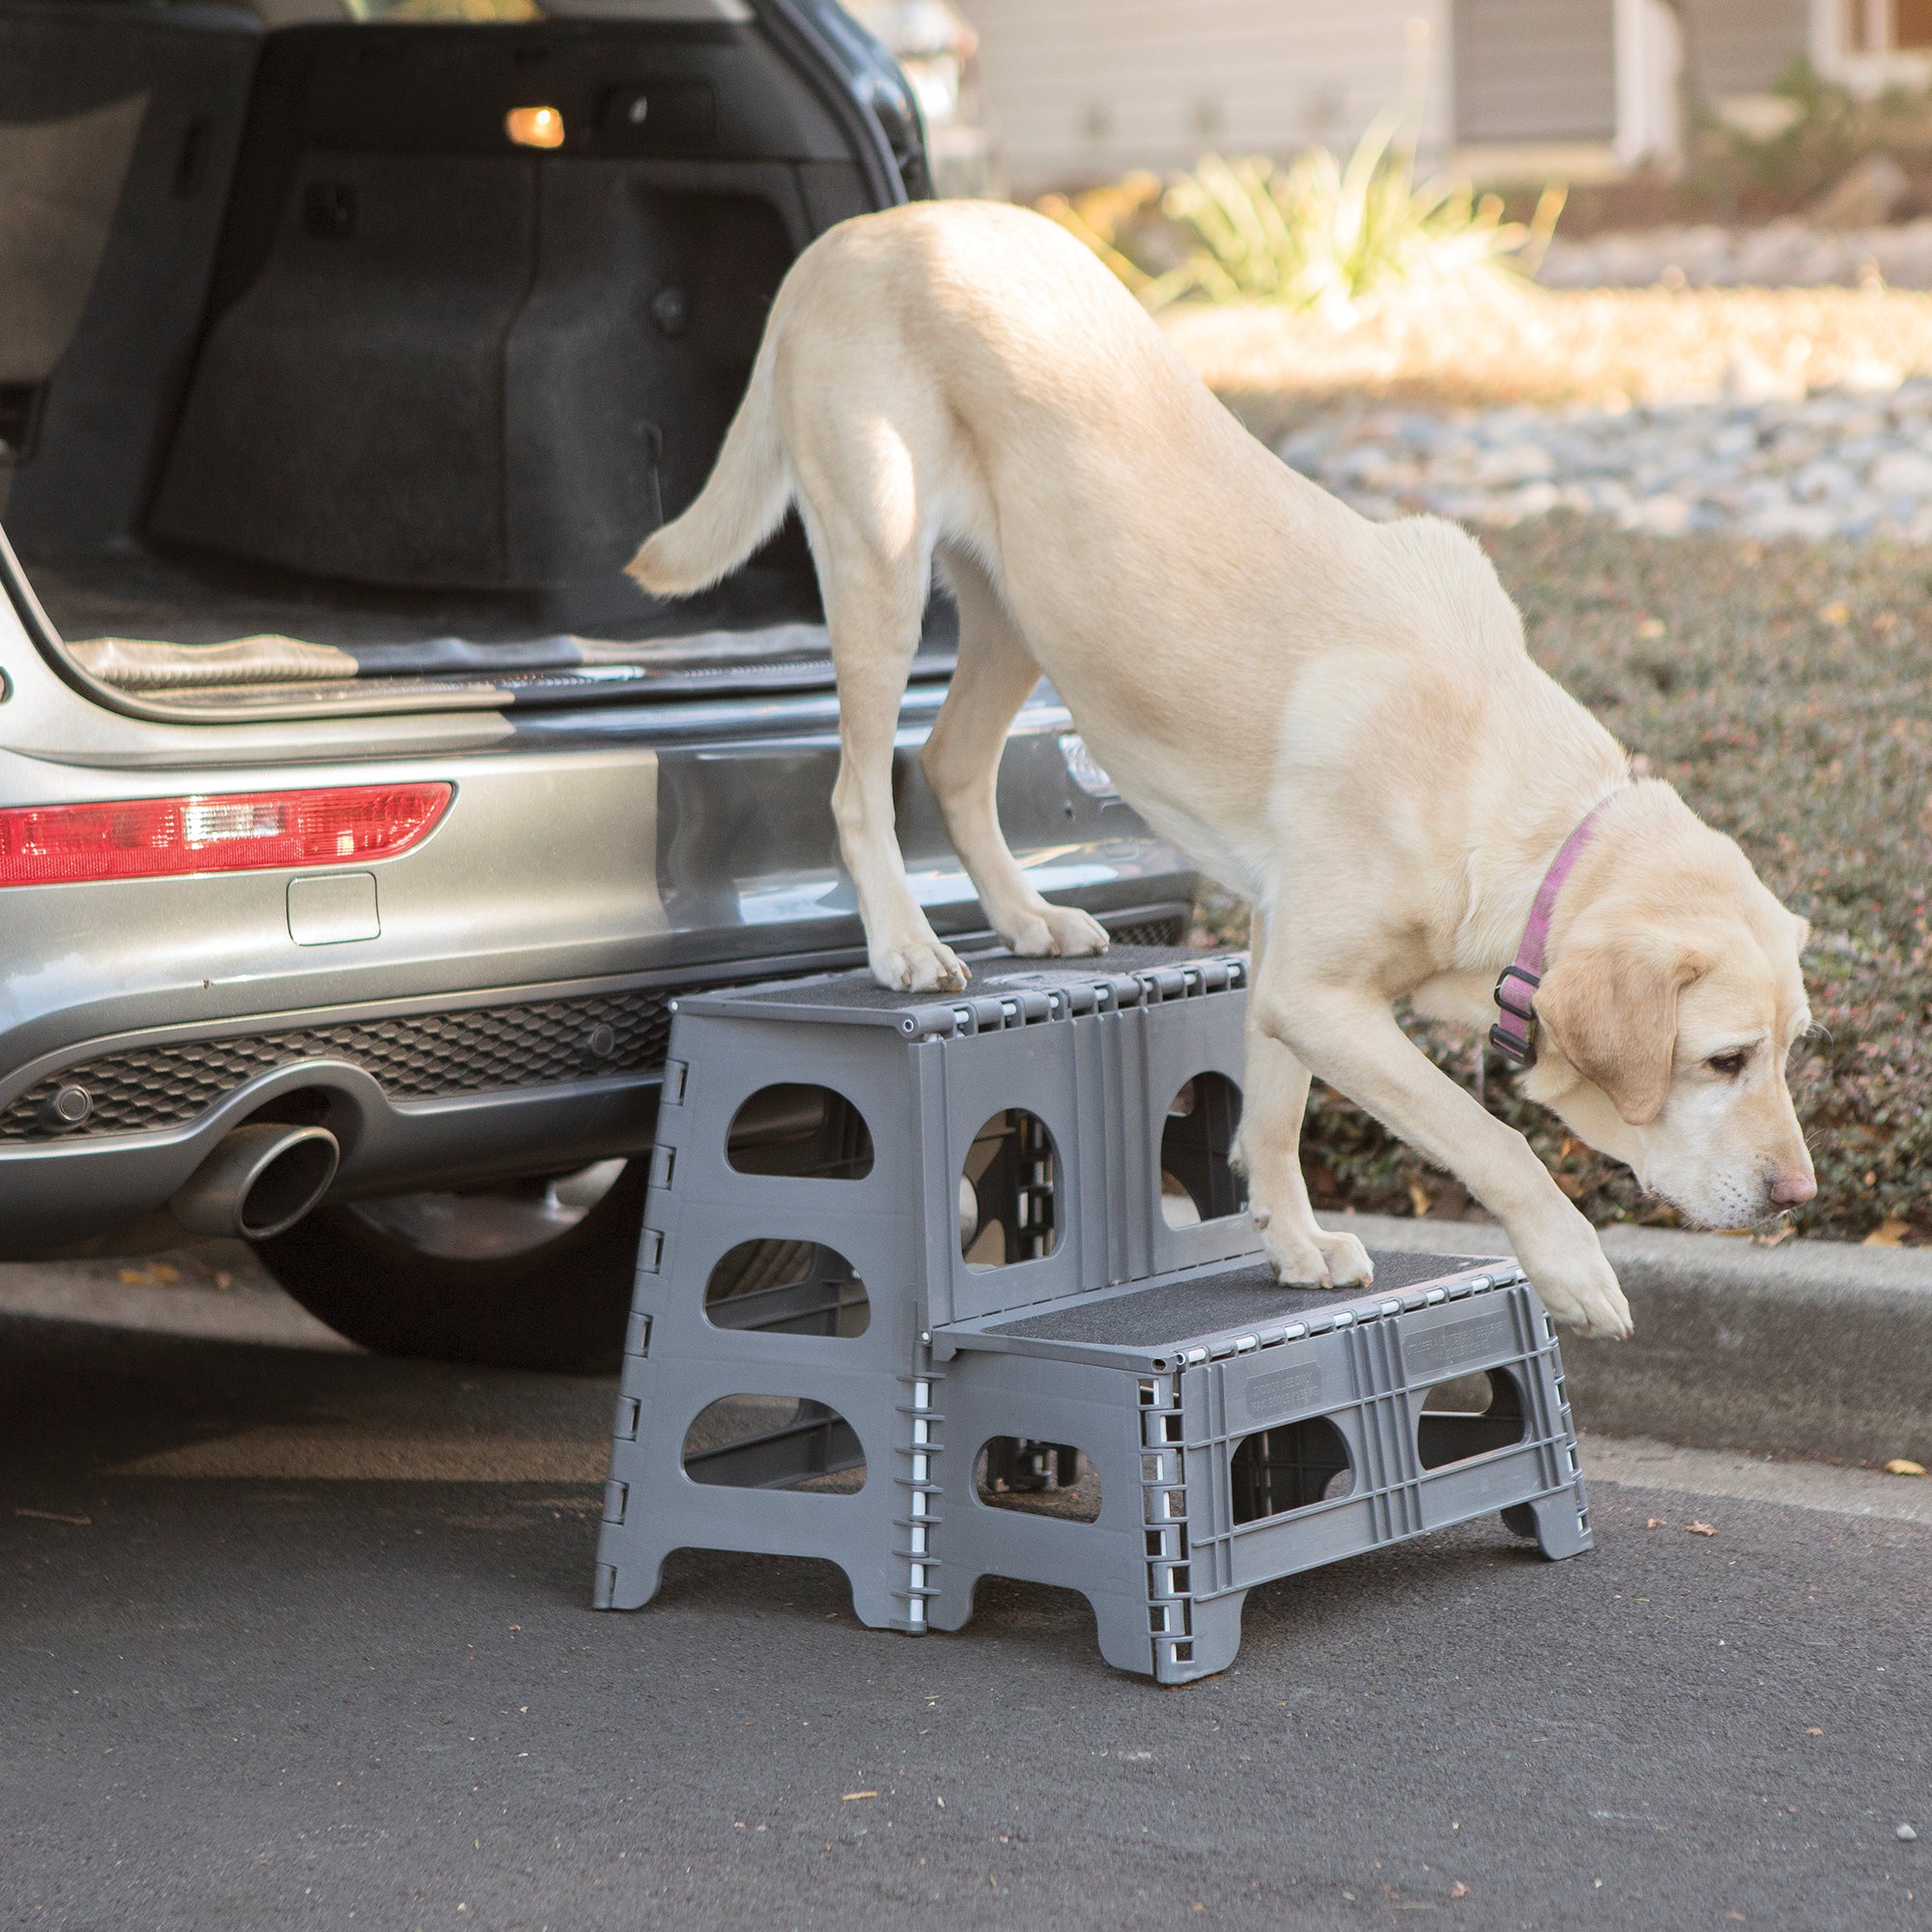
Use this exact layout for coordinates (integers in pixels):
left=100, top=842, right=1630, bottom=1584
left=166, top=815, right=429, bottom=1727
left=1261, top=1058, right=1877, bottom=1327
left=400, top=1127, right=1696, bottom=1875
left=962, top=0, right=1453, bottom=195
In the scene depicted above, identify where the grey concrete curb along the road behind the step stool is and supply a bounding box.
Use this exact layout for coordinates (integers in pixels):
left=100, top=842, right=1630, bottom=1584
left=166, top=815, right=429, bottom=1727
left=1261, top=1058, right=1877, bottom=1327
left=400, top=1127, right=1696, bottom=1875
left=1321, top=1213, right=1932, bottom=1464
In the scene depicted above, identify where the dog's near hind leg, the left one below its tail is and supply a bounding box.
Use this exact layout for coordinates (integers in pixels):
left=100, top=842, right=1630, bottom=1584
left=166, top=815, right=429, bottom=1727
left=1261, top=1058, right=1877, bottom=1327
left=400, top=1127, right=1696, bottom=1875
left=800, top=477, right=970, bottom=993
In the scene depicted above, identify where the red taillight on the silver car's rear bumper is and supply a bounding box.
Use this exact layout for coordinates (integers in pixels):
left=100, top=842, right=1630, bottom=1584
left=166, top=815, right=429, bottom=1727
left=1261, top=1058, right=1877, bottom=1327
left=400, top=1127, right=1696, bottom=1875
left=0, top=784, right=452, bottom=885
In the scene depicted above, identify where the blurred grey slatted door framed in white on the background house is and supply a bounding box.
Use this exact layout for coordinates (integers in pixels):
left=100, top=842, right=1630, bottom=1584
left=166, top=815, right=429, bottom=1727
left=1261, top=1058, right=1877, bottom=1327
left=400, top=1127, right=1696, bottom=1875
left=1453, top=0, right=1617, bottom=141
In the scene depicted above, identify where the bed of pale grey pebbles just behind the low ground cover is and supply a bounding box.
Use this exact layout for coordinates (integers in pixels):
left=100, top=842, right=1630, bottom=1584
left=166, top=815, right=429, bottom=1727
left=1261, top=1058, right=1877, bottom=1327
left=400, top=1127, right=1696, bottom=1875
left=1275, top=377, right=1932, bottom=545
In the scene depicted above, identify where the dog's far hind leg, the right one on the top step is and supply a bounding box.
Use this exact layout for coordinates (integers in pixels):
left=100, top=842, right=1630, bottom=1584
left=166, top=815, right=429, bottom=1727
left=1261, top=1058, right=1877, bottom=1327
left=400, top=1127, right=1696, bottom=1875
left=920, top=551, right=1107, bottom=956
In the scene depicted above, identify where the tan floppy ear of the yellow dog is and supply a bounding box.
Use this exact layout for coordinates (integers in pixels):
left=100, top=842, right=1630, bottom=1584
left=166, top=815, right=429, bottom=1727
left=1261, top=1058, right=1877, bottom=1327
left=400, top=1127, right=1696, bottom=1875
left=1536, top=937, right=1708, bottom=1126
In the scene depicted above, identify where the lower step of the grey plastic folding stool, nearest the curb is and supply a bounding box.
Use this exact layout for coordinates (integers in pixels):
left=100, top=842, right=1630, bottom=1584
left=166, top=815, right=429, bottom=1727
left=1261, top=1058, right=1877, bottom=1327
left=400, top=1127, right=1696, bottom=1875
left=923, top=1254, right=1590, bottom=1683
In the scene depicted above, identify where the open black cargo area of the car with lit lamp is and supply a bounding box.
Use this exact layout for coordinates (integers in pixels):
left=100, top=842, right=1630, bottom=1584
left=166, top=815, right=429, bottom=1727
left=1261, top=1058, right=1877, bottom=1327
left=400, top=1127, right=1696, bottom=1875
left=0, top=0, right=920, bottom=715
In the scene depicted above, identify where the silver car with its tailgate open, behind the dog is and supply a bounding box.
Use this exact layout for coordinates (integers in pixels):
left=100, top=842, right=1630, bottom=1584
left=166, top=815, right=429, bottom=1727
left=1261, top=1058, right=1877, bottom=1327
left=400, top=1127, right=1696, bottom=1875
left=0, top=0, right=1194, bottom=1368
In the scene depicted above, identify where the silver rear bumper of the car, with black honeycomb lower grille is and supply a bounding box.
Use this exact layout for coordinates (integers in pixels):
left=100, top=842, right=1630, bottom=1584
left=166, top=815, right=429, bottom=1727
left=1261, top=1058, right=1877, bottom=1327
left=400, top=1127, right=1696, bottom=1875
left=0, top=692, right=1194, bottom=1260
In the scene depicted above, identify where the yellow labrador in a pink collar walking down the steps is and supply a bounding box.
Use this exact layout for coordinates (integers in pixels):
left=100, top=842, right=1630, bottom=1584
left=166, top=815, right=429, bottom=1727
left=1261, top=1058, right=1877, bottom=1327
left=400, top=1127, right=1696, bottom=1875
left=632, top=203, right=1816, bottom=1335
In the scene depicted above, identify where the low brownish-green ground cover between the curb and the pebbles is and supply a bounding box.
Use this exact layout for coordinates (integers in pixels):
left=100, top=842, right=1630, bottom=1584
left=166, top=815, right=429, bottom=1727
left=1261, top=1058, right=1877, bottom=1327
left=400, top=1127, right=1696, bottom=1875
left=1202, top=518, right=1932, bottom=1242
